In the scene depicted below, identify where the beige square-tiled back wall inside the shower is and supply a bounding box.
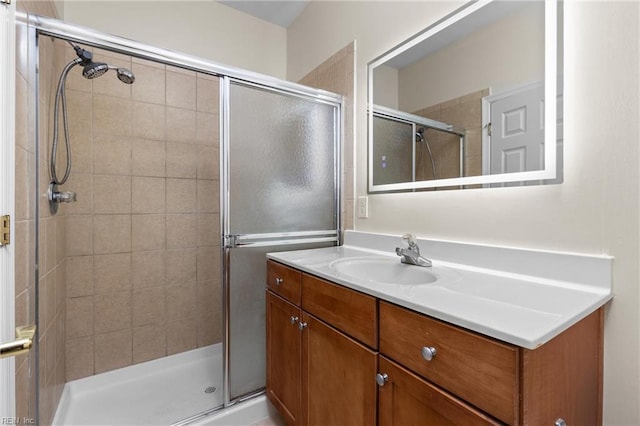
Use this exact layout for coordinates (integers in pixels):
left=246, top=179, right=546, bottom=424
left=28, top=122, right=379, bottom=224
left=66, top=49, right=222, bottom=380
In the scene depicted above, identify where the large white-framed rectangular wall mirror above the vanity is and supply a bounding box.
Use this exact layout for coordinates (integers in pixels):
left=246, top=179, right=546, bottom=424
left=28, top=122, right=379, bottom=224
left=367, top=0, right=563, bottom=192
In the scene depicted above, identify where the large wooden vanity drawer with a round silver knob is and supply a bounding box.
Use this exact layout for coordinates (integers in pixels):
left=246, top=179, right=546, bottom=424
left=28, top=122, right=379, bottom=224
left=380, top=301, right=519, bottom=424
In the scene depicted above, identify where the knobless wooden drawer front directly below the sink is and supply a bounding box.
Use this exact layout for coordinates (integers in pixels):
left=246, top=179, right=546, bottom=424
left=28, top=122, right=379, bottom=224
left=302, top=274, right=378, bottom=349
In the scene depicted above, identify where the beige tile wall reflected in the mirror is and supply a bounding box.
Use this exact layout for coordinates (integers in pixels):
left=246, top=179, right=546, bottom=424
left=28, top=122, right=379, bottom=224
left=414, top=89, right=489, bottom=184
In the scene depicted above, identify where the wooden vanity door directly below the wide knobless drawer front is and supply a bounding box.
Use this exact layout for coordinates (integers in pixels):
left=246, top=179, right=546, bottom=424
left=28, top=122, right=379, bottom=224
left=302, top=311, right=377, bottom=426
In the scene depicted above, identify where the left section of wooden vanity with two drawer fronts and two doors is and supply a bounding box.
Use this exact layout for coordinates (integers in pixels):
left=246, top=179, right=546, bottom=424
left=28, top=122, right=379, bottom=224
left=266, top=261, right=378, bottom=426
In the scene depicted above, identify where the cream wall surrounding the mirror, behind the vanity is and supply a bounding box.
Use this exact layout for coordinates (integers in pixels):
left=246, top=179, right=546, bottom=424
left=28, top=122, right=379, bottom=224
left=288, top=1, right=640, bottom=425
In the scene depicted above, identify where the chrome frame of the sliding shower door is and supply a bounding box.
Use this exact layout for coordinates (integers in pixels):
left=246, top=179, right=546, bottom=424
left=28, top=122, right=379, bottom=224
left=16, top=13, right=344, bottom=425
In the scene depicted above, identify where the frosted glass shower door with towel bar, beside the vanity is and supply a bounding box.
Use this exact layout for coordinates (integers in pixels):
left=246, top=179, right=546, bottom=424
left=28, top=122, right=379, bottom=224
left=223, top=80, right=340, bottom=400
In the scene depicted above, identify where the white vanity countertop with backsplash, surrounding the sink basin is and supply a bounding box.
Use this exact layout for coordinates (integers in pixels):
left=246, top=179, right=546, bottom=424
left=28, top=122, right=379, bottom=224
left=267, top=233, right=613, bottom=349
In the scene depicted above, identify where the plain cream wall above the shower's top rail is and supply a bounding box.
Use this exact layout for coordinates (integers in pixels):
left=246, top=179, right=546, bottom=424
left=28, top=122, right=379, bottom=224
left=63, top=0, right=287, bottom=79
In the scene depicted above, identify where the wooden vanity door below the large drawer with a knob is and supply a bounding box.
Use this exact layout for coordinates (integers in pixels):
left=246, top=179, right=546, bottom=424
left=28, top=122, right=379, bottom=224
left=378, top=356, right=501, bottom=426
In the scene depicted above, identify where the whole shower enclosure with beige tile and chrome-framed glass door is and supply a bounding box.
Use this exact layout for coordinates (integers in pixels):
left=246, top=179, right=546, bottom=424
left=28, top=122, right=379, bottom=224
left=19, top=11, right=342, bottom=424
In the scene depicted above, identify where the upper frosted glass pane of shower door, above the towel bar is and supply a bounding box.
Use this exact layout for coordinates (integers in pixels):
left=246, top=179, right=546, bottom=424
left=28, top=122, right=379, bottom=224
left=228, top=83, right=337, bottom=234
